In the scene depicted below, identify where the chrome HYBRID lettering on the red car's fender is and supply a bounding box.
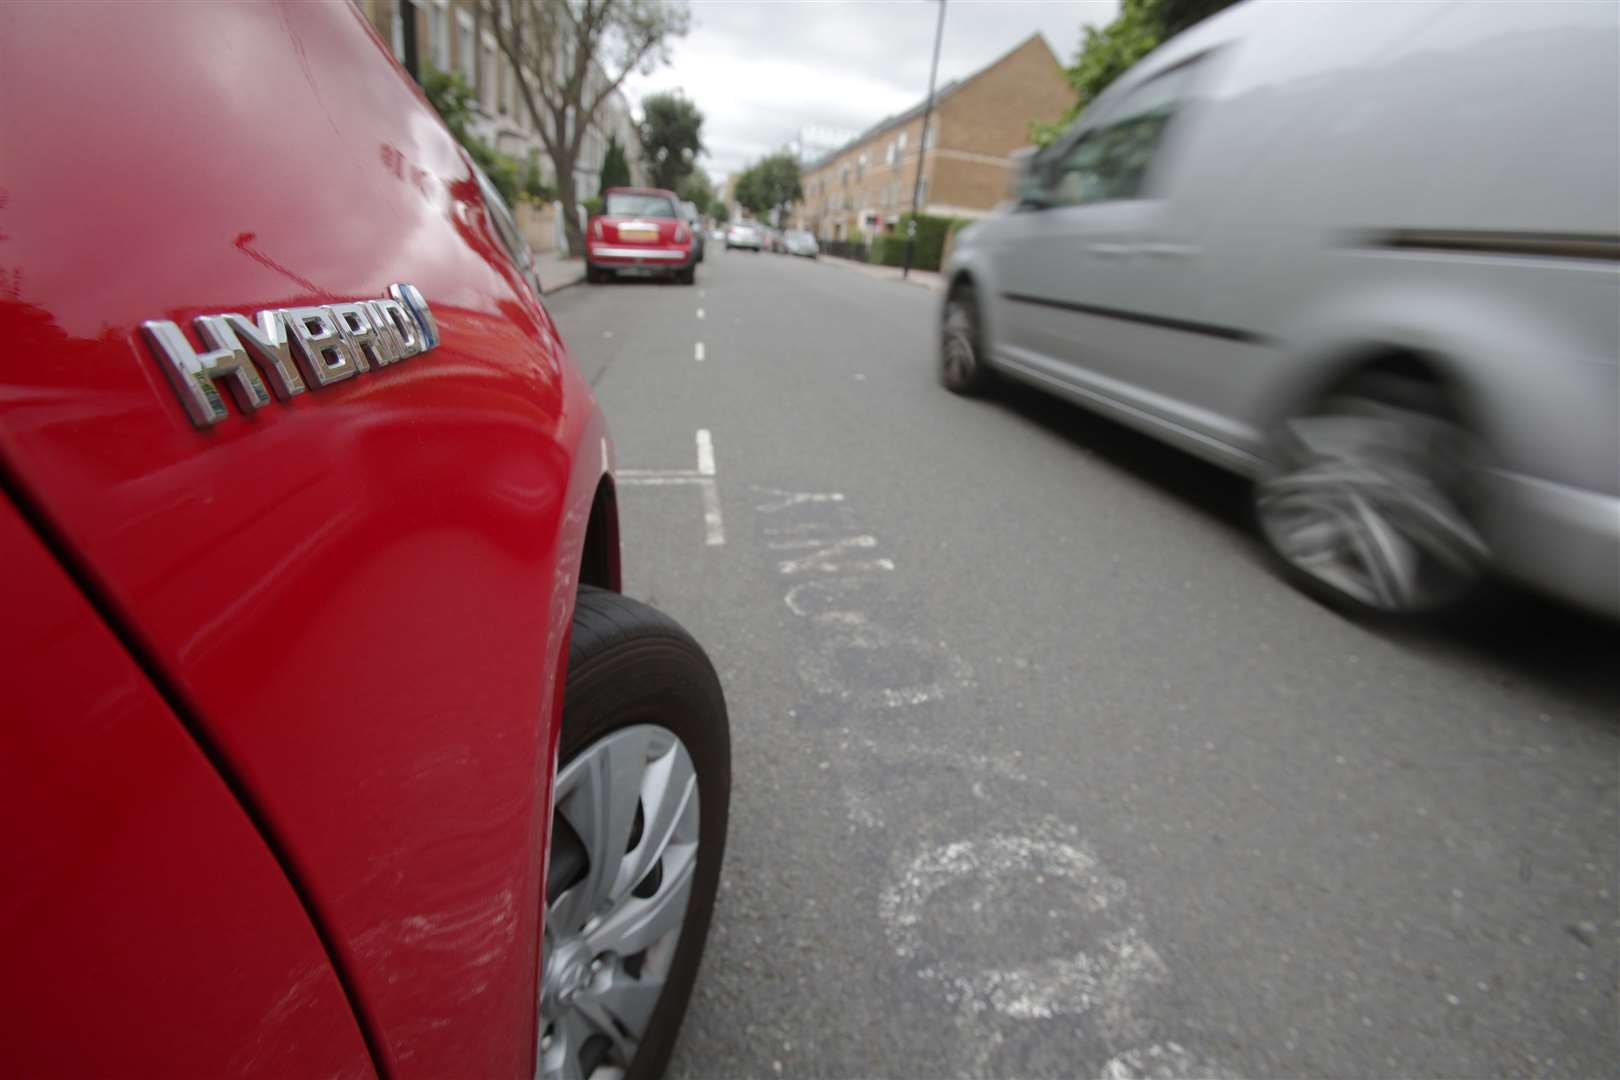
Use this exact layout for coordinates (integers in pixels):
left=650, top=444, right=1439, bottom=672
left=141, top=283, right=439, bottom=427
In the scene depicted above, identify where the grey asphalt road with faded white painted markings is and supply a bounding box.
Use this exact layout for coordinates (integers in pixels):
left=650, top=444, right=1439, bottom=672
left=548, top=249, right=1620, bottom=1080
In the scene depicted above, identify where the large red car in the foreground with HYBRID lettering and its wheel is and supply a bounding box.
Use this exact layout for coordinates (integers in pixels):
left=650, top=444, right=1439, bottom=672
left=0, top=2, right=731, bottom=1078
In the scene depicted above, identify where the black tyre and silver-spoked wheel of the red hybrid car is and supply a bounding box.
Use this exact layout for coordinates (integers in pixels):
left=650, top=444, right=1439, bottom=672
left=539, top=586, right=731, bottom=1080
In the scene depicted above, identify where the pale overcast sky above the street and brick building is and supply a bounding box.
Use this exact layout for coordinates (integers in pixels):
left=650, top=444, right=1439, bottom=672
left=625, top=0, right=1119, bottom=185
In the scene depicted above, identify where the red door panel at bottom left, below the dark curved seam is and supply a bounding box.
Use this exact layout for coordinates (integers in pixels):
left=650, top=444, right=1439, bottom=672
left=0, top=502, right=373, bottom=1078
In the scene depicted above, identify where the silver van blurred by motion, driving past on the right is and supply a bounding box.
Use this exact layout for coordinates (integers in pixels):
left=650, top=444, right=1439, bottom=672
left=941, top=3, right=1620, bottom=615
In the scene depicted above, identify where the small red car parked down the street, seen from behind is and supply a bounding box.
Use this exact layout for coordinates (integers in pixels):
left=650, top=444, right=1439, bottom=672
left=585, top=188, right=698, bottom=285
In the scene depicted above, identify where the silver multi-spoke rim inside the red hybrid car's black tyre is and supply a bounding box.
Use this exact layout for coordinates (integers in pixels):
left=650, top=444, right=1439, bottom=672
left=538, top=724, right=698, bottom=1080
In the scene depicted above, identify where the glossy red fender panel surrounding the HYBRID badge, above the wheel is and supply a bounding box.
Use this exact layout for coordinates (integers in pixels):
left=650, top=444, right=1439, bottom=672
left=0, top=2, right=617, bottom=1077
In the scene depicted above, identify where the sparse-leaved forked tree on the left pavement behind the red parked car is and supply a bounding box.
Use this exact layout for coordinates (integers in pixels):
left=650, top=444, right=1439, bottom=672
left=480, top=0, right=692, bottom=251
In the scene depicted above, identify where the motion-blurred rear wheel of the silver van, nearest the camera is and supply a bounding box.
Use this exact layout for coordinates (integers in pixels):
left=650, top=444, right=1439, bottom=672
left=1257, top=398, right=1489, bottom=614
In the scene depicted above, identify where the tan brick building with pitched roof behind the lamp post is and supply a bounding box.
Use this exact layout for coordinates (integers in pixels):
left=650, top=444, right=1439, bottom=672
left=794, top=34, right=1074, bottom=240
